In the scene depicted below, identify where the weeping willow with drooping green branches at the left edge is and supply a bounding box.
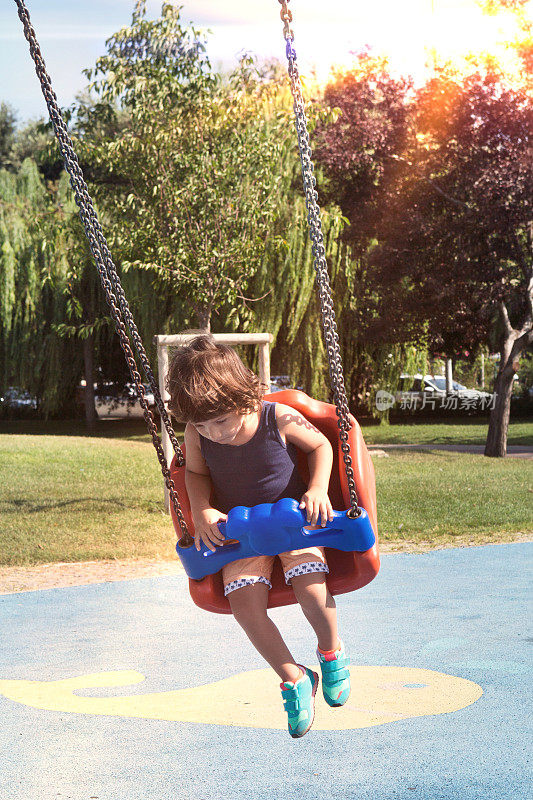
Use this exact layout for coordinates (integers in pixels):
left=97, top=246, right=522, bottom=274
left=0, top=158, right=112, bottom=424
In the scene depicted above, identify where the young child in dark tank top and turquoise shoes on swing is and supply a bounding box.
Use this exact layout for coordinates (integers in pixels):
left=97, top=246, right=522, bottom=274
left=167, top=336, right=350, bottom=738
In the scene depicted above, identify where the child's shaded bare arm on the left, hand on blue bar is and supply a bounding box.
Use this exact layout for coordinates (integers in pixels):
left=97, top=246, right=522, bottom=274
left=185, top=424, right=227, bottom=550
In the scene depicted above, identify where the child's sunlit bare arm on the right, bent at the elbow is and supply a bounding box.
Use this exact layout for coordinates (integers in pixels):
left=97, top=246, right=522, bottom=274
left=276, top=403, right=333, bottom=526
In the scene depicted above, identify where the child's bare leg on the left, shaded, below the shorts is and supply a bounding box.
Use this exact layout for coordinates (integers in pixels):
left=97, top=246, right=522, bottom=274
left=228, top=583, right=301, bottom=681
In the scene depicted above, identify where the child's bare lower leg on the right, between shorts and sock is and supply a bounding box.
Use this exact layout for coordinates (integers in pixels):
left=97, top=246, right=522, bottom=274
left=291, top=572, right=339, bottom=650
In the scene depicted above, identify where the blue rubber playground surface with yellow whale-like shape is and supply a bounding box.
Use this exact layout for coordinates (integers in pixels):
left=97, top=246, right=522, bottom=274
left=0, top=543, right=533, bottom=800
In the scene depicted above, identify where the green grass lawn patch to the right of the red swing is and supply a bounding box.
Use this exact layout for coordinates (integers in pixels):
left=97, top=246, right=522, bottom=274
left=374, top=451, right=533, bottom=545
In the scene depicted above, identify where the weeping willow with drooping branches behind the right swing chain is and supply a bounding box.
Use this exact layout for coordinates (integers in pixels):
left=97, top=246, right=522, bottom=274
left=243, top=195, right=425, bottom=421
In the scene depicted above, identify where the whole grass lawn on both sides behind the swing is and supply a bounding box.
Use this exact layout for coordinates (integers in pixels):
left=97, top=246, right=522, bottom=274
left=0, top=420, right=533, bottom=565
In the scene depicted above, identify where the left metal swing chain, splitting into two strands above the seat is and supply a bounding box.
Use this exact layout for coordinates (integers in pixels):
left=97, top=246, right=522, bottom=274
left=15, top=0, right=193, bottom=547
